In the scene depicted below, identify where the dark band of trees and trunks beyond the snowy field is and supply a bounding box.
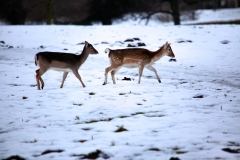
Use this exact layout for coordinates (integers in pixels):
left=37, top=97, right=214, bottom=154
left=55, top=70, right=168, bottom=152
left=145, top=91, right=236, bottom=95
left=0, top=0, right=240, bottom=25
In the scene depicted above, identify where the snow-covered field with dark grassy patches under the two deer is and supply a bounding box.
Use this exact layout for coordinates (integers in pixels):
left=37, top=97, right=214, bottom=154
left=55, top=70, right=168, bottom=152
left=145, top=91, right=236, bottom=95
left=0, top=12, right=240, bottom=160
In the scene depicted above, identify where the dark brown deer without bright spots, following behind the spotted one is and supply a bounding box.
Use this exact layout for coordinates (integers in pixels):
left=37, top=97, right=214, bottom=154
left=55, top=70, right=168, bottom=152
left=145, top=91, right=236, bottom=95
left=35, top=41, right=98, bottom=90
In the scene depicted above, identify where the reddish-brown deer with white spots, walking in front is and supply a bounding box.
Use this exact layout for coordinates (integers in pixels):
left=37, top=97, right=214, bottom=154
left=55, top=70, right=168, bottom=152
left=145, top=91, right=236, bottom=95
left=103, top=42, right=175, bottom=85
